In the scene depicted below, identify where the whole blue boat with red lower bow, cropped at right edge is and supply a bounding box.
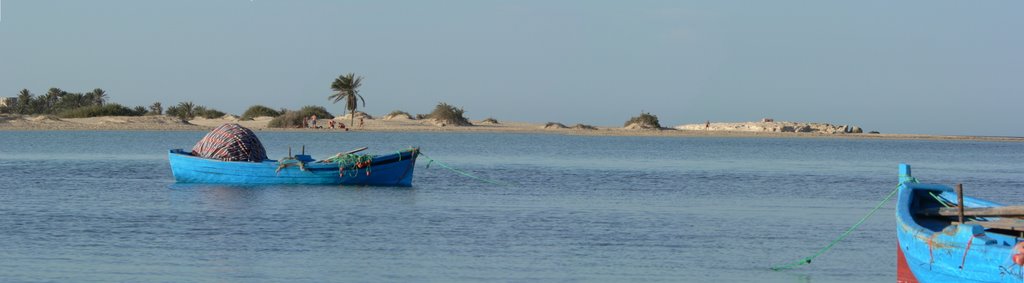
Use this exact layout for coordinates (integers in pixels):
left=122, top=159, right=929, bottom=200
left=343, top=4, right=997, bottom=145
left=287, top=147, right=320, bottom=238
left=896, top=164, right=1024, bottom=282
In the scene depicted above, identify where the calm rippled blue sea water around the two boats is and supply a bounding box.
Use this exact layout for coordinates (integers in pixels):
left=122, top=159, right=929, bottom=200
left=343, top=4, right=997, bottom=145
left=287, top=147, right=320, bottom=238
left=0, top=131, right=1024, bottom=282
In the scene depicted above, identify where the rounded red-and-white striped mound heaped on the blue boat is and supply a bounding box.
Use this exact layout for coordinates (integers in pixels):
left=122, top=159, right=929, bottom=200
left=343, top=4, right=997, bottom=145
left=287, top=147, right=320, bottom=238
left=191, top=123, right=267, bottom=162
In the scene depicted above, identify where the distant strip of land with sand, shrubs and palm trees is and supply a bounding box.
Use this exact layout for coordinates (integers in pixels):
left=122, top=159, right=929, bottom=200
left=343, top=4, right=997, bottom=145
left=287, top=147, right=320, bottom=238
left=0, top=78, right=1024, bottom=142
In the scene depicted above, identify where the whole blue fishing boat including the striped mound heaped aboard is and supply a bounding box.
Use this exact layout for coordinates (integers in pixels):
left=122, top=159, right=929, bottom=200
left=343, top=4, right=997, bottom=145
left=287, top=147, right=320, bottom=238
left=167, top=124, right=420, bottom=187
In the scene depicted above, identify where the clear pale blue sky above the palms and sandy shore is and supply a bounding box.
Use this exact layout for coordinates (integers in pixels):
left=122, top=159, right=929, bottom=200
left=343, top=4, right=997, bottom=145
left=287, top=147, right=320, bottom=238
left=0, top=0, right=1024, bottom=136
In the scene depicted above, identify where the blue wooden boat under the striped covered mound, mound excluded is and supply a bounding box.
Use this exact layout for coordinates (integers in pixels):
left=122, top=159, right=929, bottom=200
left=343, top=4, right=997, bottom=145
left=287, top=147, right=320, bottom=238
left=168, top=148, right=419, bottom=187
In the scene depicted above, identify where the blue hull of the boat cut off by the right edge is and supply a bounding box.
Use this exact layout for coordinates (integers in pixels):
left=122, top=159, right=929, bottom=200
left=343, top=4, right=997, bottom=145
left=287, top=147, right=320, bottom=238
left=896, top=166, right=1022, bottom=282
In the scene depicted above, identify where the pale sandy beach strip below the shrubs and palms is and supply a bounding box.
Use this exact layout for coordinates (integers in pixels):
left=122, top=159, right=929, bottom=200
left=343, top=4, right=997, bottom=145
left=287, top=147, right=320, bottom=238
left=0, top=115, right=1024, bottom=143
